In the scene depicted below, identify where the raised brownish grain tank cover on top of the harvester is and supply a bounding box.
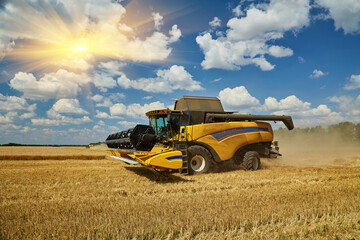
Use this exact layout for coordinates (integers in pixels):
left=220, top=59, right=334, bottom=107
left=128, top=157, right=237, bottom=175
left=175, top=96, right=224, bottom=113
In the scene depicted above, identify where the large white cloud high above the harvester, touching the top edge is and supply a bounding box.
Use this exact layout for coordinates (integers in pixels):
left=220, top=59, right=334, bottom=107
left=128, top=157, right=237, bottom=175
left=196, top=0, right=310, bottom=71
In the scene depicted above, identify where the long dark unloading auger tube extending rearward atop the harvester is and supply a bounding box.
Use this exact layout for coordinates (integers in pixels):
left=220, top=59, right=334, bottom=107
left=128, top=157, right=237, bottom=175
left=205, top=113, right=294, bottom=130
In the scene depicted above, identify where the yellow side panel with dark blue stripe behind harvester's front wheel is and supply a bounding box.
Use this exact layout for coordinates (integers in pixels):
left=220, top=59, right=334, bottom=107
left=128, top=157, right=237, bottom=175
left=188, top=122, right=273, bottom=160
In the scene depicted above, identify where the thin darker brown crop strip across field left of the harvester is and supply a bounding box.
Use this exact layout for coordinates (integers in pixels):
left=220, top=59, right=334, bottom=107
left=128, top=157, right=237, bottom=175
left=0, top=155, right=106, bottom=160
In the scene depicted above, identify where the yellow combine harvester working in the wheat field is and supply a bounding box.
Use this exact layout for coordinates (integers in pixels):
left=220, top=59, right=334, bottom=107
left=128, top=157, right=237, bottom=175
left=106, top=97, right=294, bottom=174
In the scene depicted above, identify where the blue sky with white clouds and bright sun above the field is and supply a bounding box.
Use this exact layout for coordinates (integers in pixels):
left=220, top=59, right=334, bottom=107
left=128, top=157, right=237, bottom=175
left=0, top=0, right=360, bottom=144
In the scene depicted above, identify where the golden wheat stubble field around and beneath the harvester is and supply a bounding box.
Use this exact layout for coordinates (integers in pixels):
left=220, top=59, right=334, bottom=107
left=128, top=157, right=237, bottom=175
left=0, top=143, right=360, bottom=239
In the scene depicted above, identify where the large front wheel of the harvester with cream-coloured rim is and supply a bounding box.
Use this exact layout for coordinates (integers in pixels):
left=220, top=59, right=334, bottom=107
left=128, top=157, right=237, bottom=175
left=188, top=146, right=213, bottom=175
